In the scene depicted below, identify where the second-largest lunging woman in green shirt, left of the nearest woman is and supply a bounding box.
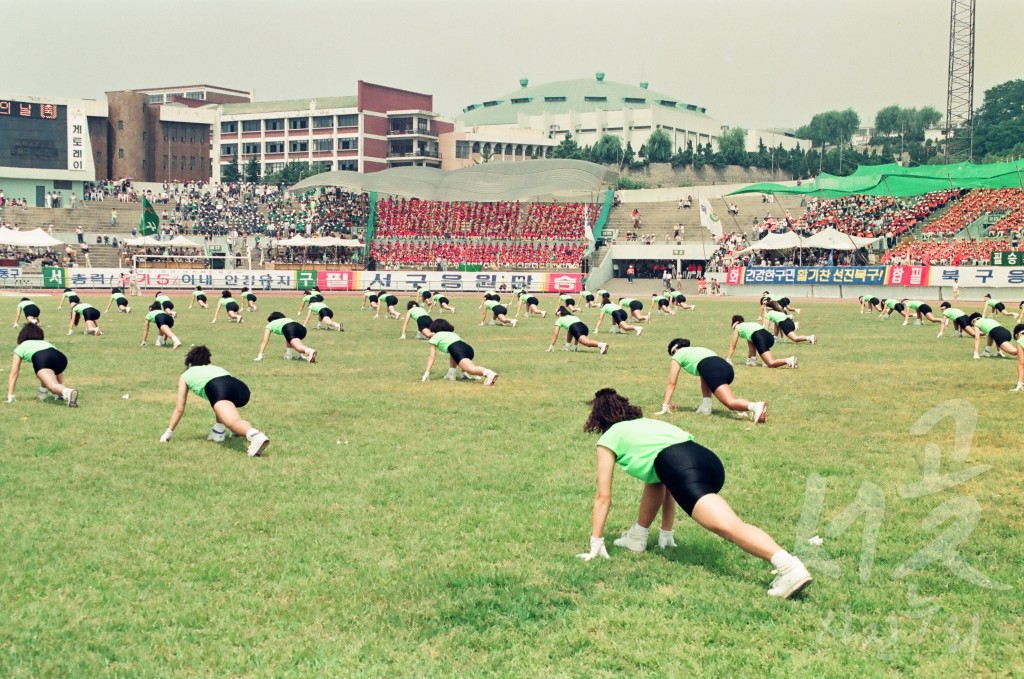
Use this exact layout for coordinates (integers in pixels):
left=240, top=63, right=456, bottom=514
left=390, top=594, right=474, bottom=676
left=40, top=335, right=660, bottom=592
left=160, top=344, right=270, bottom=458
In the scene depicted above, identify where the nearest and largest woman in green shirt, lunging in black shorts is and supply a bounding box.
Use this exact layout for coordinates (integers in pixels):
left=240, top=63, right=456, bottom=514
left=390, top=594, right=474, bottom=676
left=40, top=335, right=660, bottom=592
left=578, top=389, right=811, bottom=598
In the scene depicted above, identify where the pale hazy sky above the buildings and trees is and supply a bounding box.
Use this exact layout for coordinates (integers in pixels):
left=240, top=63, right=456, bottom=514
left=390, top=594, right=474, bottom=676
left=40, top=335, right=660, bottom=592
left=8, top=0, right=1024, bottom=128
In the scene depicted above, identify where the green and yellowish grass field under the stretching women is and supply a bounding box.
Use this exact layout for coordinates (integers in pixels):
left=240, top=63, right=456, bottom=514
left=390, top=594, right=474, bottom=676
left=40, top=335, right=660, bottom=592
left=0, top=294, right=1024, bottom=677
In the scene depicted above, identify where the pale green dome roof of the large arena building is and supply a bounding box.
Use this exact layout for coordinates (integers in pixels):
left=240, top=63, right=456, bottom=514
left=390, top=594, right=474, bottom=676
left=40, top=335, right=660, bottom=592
left=459, top=73, right=707, bottom=127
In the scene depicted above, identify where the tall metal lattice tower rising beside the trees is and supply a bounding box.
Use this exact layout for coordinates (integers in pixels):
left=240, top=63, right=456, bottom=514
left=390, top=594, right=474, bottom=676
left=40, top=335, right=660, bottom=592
left=946, top=0, right=976, bottom=162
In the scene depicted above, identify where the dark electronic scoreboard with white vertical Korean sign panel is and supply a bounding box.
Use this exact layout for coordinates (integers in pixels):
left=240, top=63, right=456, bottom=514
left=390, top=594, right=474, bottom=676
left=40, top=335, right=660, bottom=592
left=0, top=99, right=89, bottom=171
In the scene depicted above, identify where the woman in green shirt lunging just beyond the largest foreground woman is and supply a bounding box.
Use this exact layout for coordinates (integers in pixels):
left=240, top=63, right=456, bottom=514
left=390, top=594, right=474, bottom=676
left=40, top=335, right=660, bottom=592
left=657, top=337, right=768, bottom=424
